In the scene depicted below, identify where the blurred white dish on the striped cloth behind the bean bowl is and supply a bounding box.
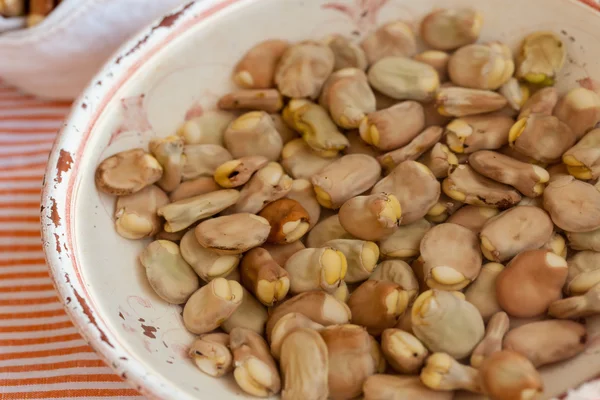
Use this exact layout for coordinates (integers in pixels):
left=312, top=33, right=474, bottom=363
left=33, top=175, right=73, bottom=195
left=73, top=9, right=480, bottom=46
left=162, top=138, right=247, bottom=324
left=0, top=0, right=185, bottom=100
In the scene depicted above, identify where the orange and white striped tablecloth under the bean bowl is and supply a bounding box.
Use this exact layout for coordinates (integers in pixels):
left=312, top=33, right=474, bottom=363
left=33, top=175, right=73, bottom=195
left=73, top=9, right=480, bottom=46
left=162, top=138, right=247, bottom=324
left=0, top=82, right=144, bottom=400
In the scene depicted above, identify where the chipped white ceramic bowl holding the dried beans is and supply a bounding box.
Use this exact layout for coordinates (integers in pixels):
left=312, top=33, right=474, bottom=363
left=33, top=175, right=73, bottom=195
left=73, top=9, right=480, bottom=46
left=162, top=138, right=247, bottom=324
left=42, top=0, right=600, bottom=400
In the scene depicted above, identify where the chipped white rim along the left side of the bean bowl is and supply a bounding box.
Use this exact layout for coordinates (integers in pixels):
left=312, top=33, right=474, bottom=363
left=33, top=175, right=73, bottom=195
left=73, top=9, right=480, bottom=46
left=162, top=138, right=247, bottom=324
left=40, top=0, right=246, bottom=400
